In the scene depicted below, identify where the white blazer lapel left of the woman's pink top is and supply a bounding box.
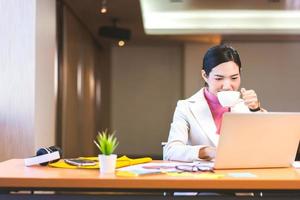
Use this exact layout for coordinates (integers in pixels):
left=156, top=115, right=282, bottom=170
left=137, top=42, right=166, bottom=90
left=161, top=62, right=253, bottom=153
left=187, top=88, right=219, bottom=146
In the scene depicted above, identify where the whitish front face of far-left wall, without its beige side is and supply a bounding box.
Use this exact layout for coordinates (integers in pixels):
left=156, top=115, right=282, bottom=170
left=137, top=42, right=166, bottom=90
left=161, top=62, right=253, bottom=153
left=0, top=0, right=36, bottom=160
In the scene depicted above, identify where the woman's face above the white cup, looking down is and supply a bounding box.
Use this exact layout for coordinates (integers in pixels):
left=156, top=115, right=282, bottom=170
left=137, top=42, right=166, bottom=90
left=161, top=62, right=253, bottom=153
left=202, top=61, right=241, bottom=95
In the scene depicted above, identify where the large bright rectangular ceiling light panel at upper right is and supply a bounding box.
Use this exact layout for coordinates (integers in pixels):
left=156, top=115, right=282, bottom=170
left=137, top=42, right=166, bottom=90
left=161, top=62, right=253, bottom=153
left=140, top=0, right=300, bottom=35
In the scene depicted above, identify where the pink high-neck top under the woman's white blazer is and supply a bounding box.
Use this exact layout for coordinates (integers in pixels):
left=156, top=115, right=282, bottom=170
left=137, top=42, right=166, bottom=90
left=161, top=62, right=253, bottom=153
left=204, top=88, right=230, bottom=134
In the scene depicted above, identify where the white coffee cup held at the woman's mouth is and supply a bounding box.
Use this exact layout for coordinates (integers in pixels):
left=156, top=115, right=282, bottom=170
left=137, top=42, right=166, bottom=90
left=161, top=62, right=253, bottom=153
left=217, top=91, right=240, bottom=107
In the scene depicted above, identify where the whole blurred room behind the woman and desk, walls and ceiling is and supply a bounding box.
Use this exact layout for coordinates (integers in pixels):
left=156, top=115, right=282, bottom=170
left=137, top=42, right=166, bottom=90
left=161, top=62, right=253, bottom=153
left=0, top=0, right=300, bottom=161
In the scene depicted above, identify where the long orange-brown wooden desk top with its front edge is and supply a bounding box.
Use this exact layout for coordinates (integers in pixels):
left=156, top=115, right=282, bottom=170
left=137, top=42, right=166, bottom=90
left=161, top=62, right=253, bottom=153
left=0, top=159, right=300, bottom=190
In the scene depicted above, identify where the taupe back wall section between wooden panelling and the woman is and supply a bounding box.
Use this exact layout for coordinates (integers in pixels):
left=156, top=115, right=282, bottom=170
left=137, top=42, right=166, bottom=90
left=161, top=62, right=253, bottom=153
left=111, top=45, right=182, bottom=156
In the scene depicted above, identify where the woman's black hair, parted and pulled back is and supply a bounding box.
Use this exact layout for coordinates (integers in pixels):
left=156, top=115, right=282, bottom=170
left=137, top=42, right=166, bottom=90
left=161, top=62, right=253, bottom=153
left=202, top=44, right=242, bottom=76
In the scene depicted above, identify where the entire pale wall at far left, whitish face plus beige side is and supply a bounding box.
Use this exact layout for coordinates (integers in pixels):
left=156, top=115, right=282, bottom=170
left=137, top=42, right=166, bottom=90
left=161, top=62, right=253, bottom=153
left=0, top=0, right=56, bottom=160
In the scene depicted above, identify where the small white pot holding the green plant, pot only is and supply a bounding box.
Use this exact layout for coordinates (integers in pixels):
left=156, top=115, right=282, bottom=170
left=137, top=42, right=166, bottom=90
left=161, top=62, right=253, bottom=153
left=98, top=154, right=117, bottom=174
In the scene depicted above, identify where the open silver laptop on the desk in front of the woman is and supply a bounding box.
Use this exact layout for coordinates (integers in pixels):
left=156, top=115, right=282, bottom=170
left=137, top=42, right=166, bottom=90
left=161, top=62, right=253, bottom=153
left=214, top=112, right=300, bottom=169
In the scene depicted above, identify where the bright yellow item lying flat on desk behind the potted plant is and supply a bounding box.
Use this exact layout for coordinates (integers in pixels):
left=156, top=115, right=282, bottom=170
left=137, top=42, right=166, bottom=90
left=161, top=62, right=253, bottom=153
left=48, top=156, right=152, bottom=169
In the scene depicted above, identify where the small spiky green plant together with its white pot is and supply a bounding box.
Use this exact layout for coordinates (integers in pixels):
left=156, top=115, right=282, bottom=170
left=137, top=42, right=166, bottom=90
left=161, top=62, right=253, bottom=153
left=94, top=130, right=119, bottom=174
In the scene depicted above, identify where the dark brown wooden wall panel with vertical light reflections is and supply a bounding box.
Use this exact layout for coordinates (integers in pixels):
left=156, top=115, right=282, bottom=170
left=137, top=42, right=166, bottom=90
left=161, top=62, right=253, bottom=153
left=61, top=7, right=96, bottom=157
